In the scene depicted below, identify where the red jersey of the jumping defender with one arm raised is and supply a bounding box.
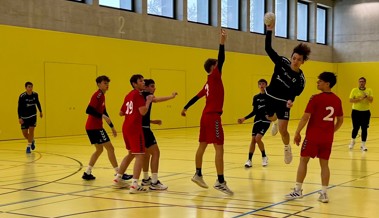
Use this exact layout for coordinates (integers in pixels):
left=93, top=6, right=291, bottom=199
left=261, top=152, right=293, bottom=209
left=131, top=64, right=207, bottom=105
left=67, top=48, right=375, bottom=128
left=197, top=66, right=224, bottom=114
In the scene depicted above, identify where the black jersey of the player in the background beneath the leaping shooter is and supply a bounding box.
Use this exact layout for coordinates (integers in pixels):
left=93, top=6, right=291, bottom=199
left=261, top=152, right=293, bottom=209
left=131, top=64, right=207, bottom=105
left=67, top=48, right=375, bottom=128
left=245, top=93, right=270, bottom=123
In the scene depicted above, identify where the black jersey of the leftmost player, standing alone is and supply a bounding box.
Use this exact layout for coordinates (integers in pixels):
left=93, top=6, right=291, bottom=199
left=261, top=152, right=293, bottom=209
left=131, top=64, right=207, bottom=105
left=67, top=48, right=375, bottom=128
left=18, top=92, right=42, bottom=119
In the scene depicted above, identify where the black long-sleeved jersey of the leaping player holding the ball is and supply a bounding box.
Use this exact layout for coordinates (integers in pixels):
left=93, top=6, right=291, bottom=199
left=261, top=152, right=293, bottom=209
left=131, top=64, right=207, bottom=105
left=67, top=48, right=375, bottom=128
left=265, top=31, right=305, bottom=101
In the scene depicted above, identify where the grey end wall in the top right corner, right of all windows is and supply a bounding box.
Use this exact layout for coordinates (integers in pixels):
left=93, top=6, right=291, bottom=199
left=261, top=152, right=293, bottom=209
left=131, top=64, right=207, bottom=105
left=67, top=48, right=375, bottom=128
left=333, top=0, right=379, bottom=62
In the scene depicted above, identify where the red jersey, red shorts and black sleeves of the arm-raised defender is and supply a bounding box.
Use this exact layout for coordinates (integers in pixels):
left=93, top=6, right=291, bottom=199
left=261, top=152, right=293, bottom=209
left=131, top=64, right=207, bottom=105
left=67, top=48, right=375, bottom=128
left=184, top=45, right=225, bottom=145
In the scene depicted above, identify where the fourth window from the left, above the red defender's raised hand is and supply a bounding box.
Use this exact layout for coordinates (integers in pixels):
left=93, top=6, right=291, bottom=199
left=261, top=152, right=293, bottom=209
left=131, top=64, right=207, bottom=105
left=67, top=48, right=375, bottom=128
left=221, top=0, right=239, bottom=29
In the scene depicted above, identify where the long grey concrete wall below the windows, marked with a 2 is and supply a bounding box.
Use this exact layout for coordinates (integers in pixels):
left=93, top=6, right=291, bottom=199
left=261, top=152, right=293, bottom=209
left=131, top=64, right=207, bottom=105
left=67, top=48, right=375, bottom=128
left=0, top=0, right=333, bottom=62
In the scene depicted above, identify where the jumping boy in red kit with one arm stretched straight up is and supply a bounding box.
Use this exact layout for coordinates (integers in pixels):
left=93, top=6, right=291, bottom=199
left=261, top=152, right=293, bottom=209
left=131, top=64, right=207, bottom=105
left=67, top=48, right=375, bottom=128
left=181, top=29, right=233, bottom=195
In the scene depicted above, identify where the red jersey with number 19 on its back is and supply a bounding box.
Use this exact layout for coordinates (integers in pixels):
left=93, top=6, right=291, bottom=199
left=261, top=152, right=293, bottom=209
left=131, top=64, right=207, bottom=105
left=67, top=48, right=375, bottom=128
left=121, top=89, right=145, bottom=131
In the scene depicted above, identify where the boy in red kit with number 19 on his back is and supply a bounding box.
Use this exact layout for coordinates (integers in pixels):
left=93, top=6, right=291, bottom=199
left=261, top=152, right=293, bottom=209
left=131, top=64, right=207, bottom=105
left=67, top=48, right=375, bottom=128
left=114, top=74, right=153, bottom=194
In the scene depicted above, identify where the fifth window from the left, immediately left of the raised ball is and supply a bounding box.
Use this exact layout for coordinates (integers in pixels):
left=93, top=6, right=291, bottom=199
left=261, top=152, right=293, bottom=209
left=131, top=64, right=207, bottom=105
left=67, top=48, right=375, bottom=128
left=250, top=0, right=265, bottom=33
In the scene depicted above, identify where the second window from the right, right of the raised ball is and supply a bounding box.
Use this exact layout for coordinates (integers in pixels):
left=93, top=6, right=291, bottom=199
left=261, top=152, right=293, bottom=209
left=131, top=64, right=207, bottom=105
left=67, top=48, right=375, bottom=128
left=297, top=1, right=308, bottom=41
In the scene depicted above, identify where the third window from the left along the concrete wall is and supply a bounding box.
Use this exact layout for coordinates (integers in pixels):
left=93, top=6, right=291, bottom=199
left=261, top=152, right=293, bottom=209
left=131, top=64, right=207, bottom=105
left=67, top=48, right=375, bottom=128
left=187, top=0, right=209, bottom=24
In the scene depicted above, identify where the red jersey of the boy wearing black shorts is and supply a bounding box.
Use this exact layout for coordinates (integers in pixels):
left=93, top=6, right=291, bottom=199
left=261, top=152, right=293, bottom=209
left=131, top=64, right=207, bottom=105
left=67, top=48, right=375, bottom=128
left=86, top=89, right=105, bottom=130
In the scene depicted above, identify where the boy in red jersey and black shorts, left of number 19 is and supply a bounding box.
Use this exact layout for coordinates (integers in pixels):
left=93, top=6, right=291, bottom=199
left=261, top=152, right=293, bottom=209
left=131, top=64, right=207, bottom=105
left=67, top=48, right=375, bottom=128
left=82, top=76, right=131, bottom=180
